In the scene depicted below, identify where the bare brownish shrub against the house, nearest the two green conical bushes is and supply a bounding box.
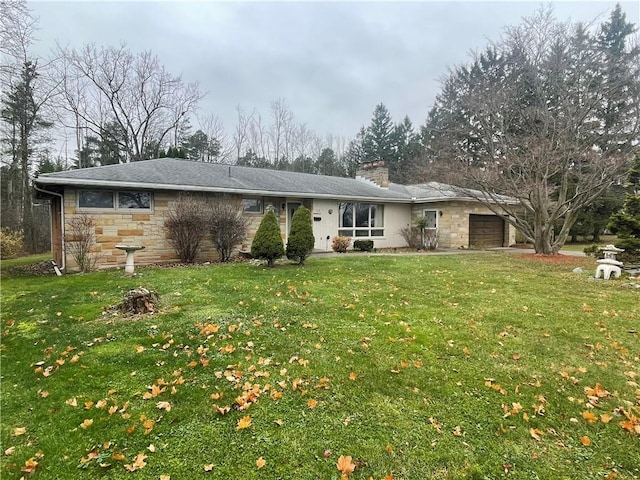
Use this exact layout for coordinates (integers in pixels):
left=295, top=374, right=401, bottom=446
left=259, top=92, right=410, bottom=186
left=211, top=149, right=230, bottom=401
left=209, top=200, right=249, bottom=262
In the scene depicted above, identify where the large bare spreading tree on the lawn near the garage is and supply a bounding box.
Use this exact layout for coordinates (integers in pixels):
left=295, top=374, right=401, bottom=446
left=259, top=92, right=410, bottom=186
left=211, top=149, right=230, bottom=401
left=424, top=6, right=640, bottom=254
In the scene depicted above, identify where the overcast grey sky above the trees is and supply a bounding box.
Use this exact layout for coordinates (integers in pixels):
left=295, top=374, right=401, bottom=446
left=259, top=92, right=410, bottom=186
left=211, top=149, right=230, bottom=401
left=29, top=0, right=640, bottom=146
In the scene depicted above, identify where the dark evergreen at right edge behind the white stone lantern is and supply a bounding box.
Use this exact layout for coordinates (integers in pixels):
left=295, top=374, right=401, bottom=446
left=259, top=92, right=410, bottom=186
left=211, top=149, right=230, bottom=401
left=609, top=152, right=640, bottom=263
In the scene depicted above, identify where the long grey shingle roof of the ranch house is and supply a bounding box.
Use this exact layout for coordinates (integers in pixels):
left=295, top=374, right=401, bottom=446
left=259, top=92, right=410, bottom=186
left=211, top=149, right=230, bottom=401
left=36, top=158, right=500, bottom=203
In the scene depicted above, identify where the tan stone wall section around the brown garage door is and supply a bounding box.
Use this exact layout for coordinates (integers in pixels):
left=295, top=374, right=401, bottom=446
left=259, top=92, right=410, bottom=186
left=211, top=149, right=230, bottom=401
left=411, top=201, right=516, bottom=248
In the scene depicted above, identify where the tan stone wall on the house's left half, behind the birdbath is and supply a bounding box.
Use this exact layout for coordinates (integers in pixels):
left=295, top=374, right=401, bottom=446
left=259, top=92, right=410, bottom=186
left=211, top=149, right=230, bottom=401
left=64, top=189, right=286, bottom=271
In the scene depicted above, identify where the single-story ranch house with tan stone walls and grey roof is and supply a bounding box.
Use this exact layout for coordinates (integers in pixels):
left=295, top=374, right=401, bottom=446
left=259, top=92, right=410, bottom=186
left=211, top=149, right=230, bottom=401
left=34, top=158, right=515, bottom=270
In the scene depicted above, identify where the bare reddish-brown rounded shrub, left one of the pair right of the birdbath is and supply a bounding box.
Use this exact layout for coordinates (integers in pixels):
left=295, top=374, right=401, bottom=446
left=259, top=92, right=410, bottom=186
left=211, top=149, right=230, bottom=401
left=164, top=193, right=209, bottom=263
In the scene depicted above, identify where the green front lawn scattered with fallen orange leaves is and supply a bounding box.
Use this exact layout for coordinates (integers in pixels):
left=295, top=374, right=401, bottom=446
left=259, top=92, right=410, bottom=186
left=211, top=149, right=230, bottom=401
left=0, top=253, right=640, bottom=480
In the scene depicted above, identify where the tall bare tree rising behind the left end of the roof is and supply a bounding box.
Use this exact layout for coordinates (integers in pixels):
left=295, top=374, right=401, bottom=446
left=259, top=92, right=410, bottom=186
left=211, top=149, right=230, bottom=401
left=54, top=44, right=203, bottom=161
